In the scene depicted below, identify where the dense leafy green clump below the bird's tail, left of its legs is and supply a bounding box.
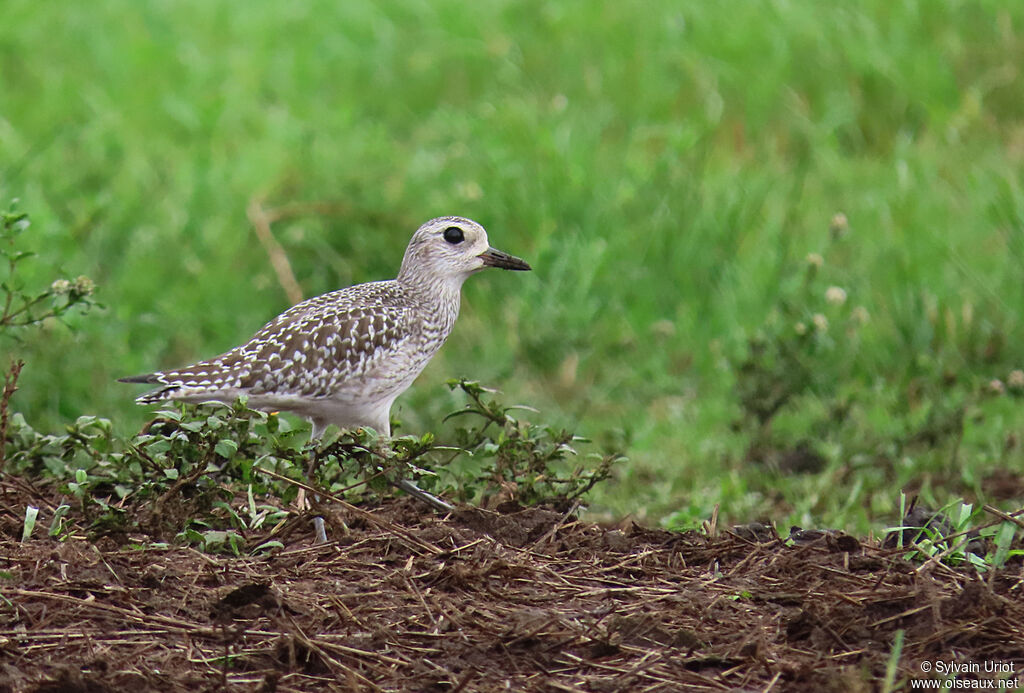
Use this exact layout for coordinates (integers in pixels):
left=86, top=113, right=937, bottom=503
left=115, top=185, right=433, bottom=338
left=8, top=402, right=305, bottom=538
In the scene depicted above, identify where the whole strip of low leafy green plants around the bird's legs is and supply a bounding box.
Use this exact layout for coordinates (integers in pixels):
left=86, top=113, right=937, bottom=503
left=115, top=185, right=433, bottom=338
left=2, top=381, right=621, bottom=555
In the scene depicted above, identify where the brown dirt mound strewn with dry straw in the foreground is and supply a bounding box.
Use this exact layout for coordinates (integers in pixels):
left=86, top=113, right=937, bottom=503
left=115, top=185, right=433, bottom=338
left=0, top=501, right=1024, bottom=693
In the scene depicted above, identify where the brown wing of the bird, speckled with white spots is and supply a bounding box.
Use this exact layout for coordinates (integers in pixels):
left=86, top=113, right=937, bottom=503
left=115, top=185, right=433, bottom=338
left=126, top=281, right=412, bottom=404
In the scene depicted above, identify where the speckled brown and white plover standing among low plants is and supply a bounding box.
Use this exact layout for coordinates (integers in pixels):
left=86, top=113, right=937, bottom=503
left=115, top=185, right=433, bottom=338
left=119, top=216, right=531, bottom=543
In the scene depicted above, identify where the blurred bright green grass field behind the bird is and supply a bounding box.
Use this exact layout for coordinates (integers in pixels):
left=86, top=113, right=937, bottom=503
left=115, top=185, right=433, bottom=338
left=0, top=0, right=1024, bottom=530
